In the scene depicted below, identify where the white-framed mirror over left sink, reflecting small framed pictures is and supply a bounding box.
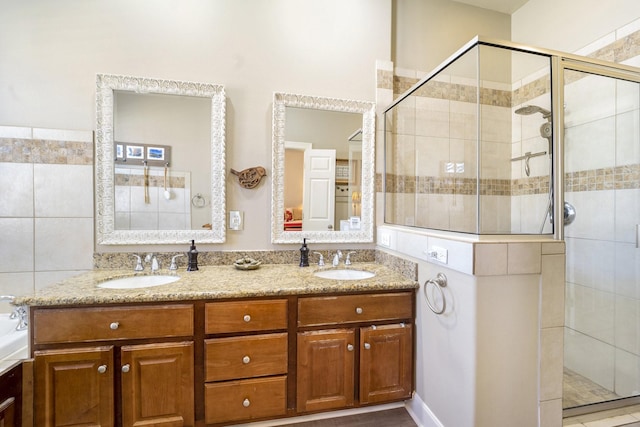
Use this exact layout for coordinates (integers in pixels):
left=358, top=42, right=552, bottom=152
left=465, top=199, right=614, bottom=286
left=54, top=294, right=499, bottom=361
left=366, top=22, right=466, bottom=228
left=95, top=74, right=226, bottom=245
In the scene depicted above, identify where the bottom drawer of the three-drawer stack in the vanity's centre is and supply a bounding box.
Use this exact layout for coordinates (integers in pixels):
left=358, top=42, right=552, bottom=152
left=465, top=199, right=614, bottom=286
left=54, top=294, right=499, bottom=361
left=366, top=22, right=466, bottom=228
left=204, top=376, right=287, bottom=424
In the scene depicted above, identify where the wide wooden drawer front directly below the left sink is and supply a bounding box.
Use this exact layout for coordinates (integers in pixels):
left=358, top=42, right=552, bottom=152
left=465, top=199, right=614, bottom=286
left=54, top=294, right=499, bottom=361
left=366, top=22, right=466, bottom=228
left=33, top=304, right=193, bottom=344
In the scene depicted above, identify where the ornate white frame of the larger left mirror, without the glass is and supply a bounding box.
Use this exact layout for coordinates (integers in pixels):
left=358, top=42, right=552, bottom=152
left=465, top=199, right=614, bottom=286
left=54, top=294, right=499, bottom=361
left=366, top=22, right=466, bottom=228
left=95, top=74, right=226, bottom=245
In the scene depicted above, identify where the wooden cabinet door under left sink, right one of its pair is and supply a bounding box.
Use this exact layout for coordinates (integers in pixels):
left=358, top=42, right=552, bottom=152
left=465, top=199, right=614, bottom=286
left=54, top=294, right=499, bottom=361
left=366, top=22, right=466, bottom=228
left=121, top=341, right=194, bottom=427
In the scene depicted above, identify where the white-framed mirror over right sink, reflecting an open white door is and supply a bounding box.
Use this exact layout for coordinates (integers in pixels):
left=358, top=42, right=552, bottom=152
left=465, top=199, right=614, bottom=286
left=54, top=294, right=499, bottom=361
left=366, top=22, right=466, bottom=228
left=271, top=92, right=375, bottom=243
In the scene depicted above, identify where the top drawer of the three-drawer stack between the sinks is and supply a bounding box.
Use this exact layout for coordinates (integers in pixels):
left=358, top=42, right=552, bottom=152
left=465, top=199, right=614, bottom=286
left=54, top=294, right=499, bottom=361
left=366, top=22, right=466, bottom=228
left=204, top=299, right=287, bottom=334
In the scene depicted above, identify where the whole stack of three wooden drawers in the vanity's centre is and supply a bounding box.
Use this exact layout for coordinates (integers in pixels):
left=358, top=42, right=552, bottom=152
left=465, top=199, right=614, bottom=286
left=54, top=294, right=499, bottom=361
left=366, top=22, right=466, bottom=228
left=204, top=299, right=289, bottom=425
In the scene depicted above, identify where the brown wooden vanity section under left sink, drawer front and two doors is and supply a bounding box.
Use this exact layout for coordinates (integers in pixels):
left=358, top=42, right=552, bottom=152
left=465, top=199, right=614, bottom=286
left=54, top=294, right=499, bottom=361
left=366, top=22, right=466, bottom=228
left=32, top=304, right=195, bottom=426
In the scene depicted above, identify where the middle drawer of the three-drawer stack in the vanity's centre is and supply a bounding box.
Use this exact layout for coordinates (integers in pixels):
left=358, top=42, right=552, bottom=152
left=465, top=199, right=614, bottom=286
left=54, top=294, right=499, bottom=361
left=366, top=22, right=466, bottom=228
left=205, top=333, right=288, bottom=381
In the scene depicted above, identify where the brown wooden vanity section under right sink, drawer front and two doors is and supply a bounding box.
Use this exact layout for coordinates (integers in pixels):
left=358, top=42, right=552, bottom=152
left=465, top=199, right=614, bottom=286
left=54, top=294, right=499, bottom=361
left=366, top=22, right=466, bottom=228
left=296, top=292, right=413, bottom=413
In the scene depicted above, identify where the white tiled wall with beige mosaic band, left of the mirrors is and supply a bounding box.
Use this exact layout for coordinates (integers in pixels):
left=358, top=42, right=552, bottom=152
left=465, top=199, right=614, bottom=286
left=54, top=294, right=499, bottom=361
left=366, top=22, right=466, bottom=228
left=0, top=126, right=93, bottom=311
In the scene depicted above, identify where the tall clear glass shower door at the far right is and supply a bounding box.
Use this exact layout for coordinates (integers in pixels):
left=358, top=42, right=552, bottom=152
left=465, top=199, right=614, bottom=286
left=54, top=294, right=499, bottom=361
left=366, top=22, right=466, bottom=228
left=563, top=70, right=640, bottom=409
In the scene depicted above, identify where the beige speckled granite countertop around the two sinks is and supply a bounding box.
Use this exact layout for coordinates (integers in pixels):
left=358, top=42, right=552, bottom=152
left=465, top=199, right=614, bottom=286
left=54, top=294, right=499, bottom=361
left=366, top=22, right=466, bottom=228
left=14, top=263, right=419, bottom=306
